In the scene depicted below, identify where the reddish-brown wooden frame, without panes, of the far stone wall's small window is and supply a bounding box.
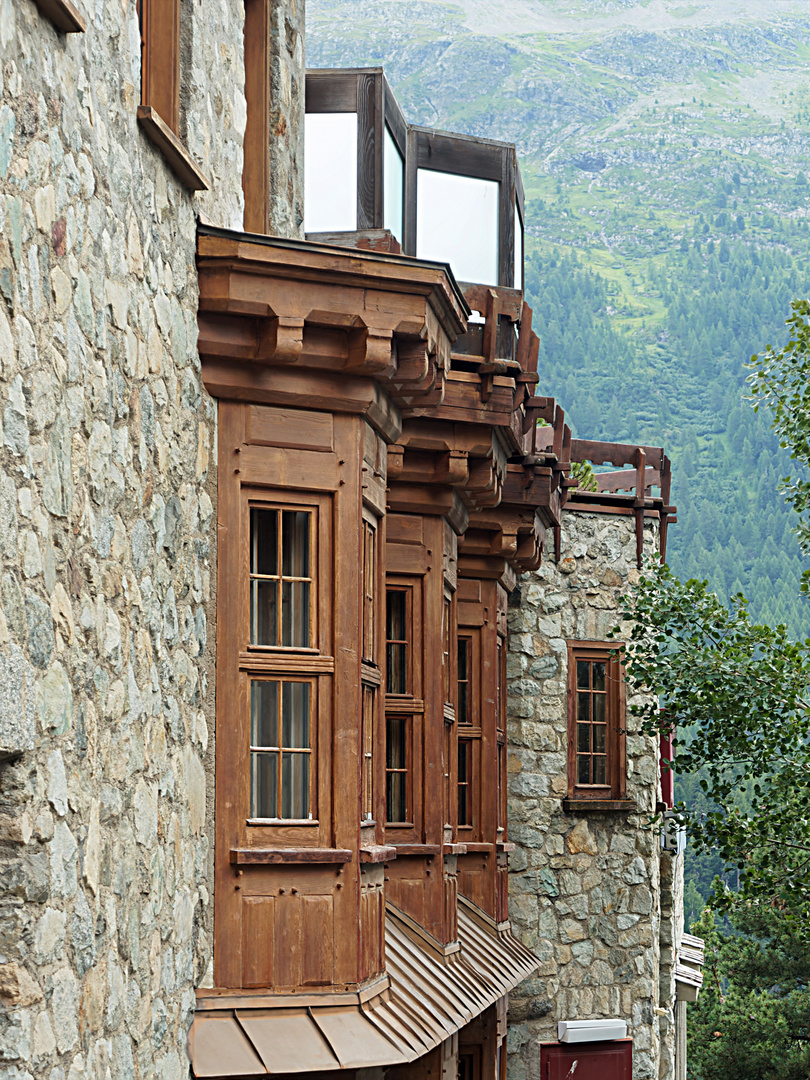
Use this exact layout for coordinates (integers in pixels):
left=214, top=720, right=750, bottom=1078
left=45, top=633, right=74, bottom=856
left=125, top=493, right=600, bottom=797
left=568, top=642, right=626, bottom=801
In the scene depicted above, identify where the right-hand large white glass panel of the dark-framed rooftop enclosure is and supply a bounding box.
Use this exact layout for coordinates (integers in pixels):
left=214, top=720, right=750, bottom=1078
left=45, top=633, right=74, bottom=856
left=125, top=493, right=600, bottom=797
left=416, top=168, right=499, bottom=285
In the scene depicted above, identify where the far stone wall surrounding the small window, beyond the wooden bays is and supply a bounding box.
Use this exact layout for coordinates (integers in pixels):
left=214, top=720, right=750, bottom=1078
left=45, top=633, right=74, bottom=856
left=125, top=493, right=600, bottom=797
left=508, top=511, right=686, bottom=1080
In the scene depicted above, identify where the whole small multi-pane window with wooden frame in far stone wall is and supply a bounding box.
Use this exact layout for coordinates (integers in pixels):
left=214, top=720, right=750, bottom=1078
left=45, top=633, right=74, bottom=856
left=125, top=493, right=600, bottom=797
left=568, top=642, right=625, bottom=800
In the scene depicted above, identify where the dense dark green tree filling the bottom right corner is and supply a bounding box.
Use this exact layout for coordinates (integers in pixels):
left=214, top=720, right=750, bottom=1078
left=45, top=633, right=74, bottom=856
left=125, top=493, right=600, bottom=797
left=689, top=905, right=810, bottom=1080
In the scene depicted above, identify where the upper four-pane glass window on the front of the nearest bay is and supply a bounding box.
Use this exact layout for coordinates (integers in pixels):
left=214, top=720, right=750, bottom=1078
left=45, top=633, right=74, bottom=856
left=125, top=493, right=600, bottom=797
left=251, top=507, right=312, bottom=649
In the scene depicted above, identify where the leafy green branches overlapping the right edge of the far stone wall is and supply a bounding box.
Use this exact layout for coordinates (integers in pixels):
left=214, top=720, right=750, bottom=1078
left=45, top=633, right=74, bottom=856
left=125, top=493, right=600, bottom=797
left=623, top=567, right=810, bottom=924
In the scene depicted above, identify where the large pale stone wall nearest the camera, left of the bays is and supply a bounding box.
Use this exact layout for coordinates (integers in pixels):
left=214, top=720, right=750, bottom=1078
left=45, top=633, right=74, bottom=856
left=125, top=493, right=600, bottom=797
left=0, top=0, right=302, bottom=1080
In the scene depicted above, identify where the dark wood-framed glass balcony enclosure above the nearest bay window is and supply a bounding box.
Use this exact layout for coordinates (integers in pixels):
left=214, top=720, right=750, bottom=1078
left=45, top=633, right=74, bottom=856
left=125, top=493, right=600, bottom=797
left=305, top=68, right=524, bottom=289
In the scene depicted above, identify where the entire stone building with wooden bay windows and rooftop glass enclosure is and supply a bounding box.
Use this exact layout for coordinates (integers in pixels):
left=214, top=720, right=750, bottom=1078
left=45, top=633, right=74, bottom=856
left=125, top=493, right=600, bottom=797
left=0, top=0, right=699, bottom=1080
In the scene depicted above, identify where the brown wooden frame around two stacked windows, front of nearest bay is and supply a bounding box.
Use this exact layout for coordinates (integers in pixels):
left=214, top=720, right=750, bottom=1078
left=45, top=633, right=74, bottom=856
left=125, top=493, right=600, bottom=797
left=237, top=487, right=334, bottom=847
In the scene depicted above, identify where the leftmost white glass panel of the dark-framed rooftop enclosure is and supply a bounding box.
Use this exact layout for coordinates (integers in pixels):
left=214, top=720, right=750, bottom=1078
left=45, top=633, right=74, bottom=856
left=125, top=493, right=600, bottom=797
left=303, top=112, right=357, bottom=232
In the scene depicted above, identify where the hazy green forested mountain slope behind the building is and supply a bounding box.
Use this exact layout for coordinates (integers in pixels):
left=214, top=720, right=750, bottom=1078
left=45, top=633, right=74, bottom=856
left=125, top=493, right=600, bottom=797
left=307, top=0, right=810, bottom=636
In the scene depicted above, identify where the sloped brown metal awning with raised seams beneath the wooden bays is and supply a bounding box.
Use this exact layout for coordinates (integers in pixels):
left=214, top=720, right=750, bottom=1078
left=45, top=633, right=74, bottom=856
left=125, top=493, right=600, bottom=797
left=189, top=897, right=537, bottom=1080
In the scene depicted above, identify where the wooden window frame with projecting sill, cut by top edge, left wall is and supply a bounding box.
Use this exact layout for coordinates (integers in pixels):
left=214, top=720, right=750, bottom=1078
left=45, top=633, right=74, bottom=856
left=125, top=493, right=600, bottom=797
left=137, top=0, right=211, bottom=191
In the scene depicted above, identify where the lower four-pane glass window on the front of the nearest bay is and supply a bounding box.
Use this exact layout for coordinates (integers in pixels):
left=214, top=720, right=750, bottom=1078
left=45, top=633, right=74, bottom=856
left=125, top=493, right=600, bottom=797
left=251, top=679, right=312, bottom=821
